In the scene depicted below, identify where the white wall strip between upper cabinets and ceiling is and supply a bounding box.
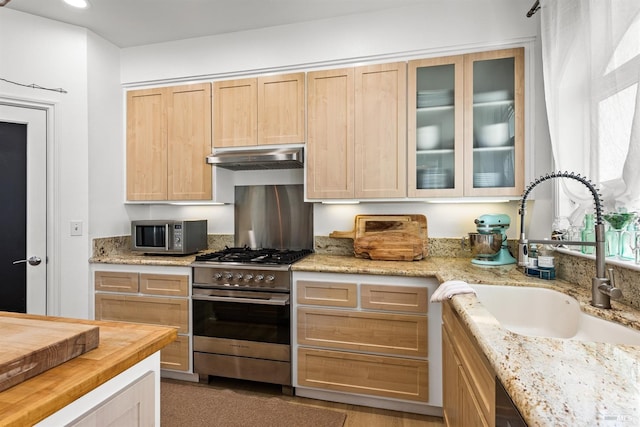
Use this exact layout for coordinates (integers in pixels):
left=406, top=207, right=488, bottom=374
left=122, top=0, right=537, bottom=84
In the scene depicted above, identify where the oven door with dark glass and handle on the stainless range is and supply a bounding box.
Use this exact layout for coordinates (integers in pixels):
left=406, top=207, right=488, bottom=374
left=192, top=288, right=291, bottom=346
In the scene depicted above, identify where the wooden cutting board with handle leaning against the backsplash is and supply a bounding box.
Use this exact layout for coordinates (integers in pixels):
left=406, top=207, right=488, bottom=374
left=329, top=214, right=428, bottom=261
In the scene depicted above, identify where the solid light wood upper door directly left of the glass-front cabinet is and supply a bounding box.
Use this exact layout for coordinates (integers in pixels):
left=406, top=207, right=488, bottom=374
left=352, top=62, right=407, bottom=198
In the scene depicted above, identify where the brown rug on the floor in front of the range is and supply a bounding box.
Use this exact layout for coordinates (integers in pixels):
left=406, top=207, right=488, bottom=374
left=160, top=381, right=346, bottom=427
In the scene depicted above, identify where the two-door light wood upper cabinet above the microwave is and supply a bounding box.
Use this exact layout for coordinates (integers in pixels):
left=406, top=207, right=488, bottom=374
left=127, top=83, right=212, bottom=201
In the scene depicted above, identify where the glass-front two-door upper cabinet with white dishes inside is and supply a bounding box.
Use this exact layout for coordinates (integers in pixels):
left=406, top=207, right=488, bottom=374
left=408, top=48, right=524, bottom=197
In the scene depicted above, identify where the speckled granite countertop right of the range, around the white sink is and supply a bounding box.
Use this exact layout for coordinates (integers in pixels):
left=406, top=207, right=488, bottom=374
left=293, top=254, right=640, bottom=426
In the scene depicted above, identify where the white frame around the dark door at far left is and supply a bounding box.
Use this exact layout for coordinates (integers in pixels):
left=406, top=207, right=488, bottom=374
left=0, top=94, right=61, bottom=316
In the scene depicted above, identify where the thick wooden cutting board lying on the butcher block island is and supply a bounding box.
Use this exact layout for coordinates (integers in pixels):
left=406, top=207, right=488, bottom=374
left=0, top=313, right=100, bottom=391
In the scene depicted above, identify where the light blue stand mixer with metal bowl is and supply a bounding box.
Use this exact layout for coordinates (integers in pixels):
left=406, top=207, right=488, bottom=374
left=469, top=214, right=517, bottom=265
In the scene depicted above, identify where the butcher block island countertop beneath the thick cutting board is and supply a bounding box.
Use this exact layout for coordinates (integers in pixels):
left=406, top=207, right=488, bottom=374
left=0, top=312, right=177, bottom=426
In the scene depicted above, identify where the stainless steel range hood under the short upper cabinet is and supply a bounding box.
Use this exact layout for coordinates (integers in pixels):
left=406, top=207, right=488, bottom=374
left=207, top=147, right=304, bottom=171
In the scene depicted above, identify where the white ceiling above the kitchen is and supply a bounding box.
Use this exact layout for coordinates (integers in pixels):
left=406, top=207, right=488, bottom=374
left=6, top=0, right=427, bottom=48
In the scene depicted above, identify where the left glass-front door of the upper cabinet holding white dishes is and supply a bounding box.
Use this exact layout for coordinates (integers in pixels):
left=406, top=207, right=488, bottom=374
left=407, top=56, right=464, bottom=197
